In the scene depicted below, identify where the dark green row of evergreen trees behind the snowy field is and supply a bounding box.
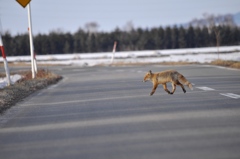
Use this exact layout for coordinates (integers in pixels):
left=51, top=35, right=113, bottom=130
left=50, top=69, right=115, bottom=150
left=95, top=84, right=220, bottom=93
left=2, top=26, right=240, bottom=56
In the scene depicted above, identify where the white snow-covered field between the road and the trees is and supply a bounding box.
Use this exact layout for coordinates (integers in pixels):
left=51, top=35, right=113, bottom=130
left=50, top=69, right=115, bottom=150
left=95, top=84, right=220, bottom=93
left=0, top=46, right=240, bottom=66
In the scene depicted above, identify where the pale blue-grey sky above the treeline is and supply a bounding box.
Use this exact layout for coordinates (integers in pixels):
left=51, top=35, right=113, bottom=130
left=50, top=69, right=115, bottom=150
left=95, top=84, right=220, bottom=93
left=0, top=0, right=240, bottom=35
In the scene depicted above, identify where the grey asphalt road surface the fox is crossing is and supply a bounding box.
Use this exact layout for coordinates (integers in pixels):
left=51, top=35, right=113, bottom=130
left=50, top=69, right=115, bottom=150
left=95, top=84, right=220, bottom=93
left=0, top=65, right=240, bottom=159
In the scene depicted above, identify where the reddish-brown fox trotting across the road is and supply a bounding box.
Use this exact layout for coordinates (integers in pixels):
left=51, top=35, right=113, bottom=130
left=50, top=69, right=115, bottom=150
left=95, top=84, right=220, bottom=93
left=143, top=70, right=193, bottom=95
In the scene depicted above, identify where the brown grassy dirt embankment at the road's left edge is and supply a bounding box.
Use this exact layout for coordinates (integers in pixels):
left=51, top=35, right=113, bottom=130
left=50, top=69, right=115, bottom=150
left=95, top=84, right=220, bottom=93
left=0, top=69, right=62, bottom=113
